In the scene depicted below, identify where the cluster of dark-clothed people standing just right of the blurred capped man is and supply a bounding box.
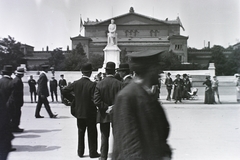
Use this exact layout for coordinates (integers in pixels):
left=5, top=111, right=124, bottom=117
left=165, top=72, right=192, bottom=103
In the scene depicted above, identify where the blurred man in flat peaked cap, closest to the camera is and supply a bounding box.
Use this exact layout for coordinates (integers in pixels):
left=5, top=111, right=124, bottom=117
left=112, top=51, right=171, bottom=160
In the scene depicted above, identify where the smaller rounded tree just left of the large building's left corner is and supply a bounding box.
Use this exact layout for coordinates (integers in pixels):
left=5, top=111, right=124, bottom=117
left=48, top=48, right=65, bottom=71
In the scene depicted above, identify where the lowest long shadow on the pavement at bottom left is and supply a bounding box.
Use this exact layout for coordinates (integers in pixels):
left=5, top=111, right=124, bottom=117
left=13, top=145, right=61, bottom=152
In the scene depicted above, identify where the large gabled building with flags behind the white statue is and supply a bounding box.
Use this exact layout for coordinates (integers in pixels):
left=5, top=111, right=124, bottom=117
left=70, top=7, right=188, bottom=63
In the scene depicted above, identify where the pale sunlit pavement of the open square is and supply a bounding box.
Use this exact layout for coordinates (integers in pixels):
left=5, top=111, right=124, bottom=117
left=8, top=86, right=240, bottom=160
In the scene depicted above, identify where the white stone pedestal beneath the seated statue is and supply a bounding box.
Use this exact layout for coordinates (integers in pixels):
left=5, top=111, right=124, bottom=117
left=98, top=45, right=121, bottom=73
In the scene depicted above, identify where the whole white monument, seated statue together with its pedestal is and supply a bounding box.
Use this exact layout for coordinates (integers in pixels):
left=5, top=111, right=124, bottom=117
left=98, top=19, right=121, bottom=72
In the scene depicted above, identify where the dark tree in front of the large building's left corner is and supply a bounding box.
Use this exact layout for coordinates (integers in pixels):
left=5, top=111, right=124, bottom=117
left=65, top=43, right=88, bottom=71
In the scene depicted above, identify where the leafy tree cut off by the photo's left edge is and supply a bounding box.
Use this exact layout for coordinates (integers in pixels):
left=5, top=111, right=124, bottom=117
left=0, top=36, right=24, bottom=68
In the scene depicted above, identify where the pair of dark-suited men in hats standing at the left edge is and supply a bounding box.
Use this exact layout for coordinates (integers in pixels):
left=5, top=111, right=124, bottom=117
left=0, top=65, right=24, bottom=160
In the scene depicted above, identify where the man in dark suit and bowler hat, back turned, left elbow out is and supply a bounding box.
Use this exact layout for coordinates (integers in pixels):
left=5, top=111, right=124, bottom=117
left=62, top=63, right=100, bottom=158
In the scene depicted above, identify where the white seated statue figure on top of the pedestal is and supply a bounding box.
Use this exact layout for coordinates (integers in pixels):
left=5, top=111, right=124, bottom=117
left=107, top=19, right=117, bottom=45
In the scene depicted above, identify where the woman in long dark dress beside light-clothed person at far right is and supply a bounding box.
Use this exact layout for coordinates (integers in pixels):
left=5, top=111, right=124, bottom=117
left=203, top=76, right=214, bottom=104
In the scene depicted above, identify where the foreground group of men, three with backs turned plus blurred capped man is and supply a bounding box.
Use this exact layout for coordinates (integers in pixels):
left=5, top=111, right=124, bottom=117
left=62, top=51, right=171, bottom=160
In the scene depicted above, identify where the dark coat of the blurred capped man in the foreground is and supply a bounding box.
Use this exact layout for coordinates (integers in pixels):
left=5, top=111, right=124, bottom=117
left=112, top=83, right=171, bottom=160
